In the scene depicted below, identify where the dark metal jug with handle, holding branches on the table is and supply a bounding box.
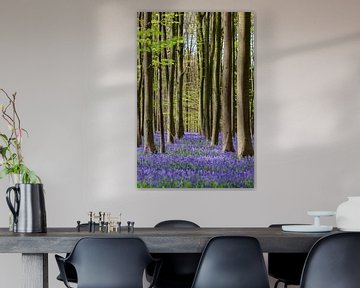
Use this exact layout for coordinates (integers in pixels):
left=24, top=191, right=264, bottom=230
left=6, top=184, right=47, bottom=233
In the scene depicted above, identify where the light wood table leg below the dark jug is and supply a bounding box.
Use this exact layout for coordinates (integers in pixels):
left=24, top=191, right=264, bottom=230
left=22, top=253, right=49, bottom=288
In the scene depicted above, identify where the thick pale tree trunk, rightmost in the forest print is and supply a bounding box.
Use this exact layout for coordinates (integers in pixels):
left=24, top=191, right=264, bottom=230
left=237, top=12, right=254, bottom=158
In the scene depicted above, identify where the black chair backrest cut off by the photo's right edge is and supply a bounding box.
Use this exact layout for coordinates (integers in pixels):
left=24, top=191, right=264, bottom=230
left=300, top=232, right=360, bottom=288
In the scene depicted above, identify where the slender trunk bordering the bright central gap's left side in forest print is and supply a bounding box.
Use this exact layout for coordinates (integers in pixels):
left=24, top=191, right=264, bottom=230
left=176, top=12, right=185, bottom=139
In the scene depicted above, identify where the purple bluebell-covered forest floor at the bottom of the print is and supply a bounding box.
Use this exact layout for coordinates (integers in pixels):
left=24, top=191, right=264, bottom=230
left=137, top=133, right=254, bottom=188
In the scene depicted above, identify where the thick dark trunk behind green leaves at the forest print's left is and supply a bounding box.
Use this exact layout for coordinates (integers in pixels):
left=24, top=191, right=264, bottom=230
left=143, top=12, right=157, bottom=153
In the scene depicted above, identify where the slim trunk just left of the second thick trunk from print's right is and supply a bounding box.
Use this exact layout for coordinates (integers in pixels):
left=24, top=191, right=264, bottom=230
left=211, top=12, right=222, bottom=146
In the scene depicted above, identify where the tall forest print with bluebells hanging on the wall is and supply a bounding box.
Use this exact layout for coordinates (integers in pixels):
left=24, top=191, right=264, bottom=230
left=137, top=12, right=255, bottom=188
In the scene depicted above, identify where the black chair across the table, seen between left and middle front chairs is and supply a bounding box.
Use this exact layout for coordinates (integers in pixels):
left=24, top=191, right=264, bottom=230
left=146, top=220, right=201, bottom=288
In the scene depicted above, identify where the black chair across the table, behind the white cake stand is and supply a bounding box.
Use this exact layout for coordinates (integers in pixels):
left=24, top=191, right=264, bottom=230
left=268, top=224, right=307, bottom=288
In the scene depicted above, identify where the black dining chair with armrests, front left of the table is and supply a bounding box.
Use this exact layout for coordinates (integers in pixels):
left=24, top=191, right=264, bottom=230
left=55, top=237, right=160, bottom=288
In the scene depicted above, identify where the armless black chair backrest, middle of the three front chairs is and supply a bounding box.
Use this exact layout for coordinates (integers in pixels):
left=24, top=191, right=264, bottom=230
left=192, top=236, right=269, bottom=288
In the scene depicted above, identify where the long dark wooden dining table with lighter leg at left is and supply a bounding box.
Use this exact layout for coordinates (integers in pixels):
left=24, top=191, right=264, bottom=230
left=0, top=227, right=338, bottom=288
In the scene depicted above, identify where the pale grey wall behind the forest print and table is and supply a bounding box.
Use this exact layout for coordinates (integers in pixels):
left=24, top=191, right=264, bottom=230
left=0, top=0, right=360, bottom=287
